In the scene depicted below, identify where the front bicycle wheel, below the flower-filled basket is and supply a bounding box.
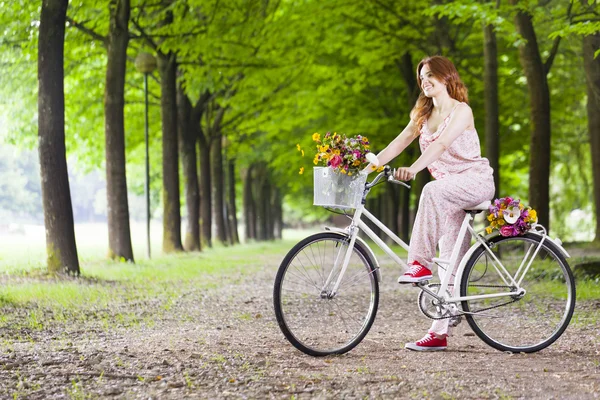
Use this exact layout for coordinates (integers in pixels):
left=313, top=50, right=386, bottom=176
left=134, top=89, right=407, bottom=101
left=273, top=232, right=379, bottom=356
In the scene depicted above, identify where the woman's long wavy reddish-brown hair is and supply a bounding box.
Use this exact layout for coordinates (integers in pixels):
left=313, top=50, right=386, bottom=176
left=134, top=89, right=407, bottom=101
left=410, top=56, right=469, bottom=136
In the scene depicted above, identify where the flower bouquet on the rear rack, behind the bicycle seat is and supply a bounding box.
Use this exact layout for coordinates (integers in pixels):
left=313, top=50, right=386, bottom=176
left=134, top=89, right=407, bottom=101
left=485, top=197, right=537, bottom=236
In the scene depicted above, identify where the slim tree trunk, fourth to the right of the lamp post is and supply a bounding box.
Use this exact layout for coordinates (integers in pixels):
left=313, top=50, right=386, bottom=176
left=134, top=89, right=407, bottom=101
left=210, top=108, right=227, bottom=245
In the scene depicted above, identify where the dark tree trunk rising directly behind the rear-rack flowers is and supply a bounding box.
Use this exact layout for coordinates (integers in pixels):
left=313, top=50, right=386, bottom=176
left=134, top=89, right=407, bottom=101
left=512, top=0, right=550, bottom=230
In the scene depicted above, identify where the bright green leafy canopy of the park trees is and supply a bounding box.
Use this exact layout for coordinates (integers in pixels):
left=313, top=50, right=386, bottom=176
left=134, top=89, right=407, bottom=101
left=0, top=0, right=600, bottom=236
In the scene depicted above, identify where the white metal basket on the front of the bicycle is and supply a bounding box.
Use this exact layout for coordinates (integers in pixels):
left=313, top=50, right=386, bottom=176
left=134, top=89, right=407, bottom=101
left=313, top=167, right=367, bottom=208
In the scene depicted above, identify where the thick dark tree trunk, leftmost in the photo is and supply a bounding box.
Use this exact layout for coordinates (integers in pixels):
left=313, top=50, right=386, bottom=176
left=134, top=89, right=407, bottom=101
left=38, top=0, right=79, bottom=275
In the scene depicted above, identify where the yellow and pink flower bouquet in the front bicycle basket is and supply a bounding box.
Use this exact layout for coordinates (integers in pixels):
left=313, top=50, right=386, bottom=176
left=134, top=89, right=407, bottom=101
left=313, top=132, right=370, bottom=176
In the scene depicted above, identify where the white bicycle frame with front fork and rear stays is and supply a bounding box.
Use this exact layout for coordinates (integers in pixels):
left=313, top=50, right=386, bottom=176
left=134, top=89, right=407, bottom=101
left=322, top=181, right=547, bottom=304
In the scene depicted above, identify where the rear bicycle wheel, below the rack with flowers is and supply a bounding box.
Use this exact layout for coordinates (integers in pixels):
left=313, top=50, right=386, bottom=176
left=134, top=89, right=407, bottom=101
left=460, top=233, right=575, bottom=353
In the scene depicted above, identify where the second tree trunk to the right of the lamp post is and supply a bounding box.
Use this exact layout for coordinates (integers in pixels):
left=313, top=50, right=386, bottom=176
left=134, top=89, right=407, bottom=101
left=177, top=85, right=200, bottom=251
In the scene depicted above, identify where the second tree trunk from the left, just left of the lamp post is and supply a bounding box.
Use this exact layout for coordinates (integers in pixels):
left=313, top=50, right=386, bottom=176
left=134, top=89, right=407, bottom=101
left=104, top=0, right=133, bottom=261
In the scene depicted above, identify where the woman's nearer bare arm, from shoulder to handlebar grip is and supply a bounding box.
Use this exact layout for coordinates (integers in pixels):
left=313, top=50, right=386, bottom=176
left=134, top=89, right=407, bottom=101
left=396, top=105, right=473, bottom=181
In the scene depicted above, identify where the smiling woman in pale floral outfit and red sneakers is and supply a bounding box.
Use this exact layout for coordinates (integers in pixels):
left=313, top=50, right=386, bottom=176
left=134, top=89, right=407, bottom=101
left=370, top=56, right=495, bottom=351
